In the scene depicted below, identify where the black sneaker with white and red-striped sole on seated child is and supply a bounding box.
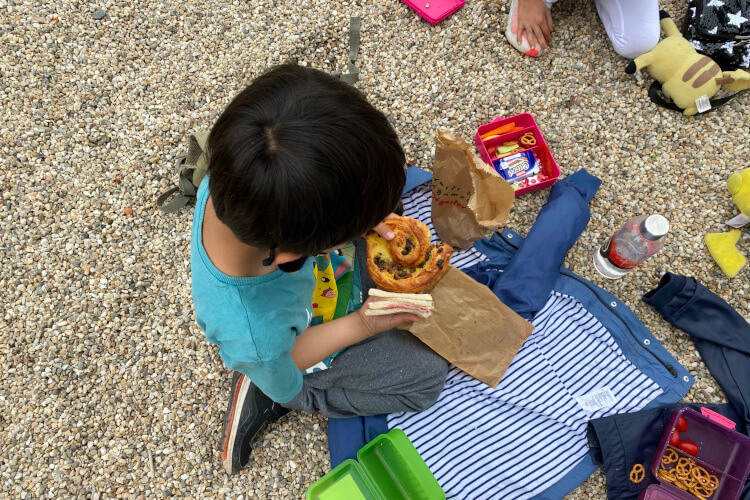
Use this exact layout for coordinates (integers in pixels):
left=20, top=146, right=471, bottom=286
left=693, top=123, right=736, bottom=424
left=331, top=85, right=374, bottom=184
left=221, top=372, right=290, bottom=474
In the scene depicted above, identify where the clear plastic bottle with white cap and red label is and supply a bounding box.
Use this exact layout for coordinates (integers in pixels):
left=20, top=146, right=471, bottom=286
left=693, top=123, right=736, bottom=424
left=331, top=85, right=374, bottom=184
left=594, top=215, right=669, bottom=279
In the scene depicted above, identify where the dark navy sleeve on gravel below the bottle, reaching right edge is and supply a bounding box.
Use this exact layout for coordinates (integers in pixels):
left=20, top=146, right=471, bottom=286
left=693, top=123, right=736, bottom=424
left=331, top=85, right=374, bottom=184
left=643, top=273, right=750, bottom=426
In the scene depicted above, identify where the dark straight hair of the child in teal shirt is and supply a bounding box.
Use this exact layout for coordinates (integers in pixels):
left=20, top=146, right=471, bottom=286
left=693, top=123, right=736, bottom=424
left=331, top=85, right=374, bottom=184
left=208, top=64, right=406, bottom=255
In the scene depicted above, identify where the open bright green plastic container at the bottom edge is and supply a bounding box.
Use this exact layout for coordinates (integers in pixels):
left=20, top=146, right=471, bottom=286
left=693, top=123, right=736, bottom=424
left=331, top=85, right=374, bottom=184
left=306, top=429, right=445, bottom=500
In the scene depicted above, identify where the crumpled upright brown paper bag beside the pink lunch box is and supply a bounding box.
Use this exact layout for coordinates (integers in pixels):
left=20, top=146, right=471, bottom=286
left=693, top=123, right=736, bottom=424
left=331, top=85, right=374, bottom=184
left=432, top=130, right=515, bottom=249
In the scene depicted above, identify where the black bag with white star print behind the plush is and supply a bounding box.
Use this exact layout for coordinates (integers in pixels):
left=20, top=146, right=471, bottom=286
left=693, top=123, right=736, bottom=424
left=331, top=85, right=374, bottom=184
left=683, top=0, right=750, bottom=71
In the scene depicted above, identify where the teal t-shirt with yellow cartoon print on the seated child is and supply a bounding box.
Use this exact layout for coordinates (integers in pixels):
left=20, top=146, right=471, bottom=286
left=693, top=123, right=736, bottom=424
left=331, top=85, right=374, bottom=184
left=190, top=177, right=361, bottom=403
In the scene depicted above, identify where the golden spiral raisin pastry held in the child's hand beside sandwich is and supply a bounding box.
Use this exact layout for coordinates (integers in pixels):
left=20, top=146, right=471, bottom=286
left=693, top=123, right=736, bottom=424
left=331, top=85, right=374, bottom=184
left=365, top=217, right=453, bottom=293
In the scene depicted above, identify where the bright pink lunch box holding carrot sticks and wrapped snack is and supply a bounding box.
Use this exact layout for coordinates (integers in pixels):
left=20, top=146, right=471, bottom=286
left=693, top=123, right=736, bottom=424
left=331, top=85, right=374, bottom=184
left=474, top=113, right=560, bottom=198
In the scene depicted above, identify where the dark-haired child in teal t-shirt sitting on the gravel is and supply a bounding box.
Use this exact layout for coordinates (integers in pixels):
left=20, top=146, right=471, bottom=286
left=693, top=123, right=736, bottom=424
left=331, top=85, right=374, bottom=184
left=191, top=64, right=447, bottom=474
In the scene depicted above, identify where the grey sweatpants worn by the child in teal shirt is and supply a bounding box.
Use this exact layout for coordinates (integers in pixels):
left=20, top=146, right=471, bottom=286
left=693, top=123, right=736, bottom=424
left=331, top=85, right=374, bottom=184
left=283, top=240, right=448, bottom=417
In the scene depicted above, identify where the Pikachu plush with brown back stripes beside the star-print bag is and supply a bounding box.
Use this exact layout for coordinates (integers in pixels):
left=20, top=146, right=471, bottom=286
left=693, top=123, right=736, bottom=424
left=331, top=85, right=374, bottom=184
left=625, top=10, right=750, bottom=116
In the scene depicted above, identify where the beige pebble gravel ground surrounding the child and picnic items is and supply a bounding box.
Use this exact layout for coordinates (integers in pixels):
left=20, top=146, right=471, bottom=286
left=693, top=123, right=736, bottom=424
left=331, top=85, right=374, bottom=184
left=0, top=0, right=750, bottom=499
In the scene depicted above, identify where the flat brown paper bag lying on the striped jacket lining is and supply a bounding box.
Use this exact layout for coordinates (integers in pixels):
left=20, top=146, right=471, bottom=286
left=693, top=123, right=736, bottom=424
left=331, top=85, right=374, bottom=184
left=405, top=266, right=534, bottom=387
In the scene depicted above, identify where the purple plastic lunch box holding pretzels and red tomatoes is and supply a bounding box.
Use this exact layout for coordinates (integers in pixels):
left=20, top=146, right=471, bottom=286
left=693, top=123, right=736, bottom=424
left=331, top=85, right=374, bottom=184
left=639, top=408, right=750, bottom=500
